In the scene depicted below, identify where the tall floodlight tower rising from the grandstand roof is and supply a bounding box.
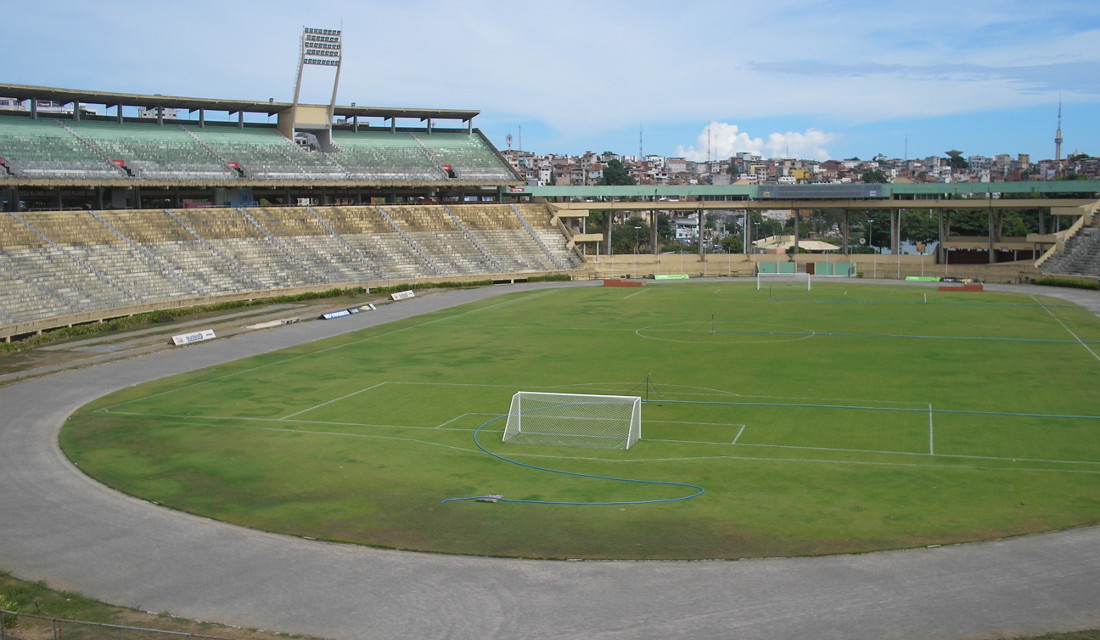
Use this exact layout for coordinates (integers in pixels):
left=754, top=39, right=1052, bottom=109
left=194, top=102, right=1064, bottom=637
left=278, top=26, right=343, bottom=151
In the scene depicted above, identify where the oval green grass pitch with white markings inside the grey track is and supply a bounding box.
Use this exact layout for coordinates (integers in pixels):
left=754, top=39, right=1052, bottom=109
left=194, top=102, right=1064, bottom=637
left=61, top=280, right=1100, bottom=559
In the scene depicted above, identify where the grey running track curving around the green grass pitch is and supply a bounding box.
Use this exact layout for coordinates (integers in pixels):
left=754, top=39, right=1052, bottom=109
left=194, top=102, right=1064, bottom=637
left=0, top=285, right=1100, bottom=640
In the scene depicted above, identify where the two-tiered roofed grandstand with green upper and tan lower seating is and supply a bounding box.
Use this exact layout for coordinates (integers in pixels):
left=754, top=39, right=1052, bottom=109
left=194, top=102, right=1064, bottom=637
left=0, top=79, right=583, bottom=340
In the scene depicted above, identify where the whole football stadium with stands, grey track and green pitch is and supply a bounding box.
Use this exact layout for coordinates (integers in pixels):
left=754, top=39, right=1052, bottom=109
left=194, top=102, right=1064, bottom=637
left=0, top=29, right=1100, bottom=639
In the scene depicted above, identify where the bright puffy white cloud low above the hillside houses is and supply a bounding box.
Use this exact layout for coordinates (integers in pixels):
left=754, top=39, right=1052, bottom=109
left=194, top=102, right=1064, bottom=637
left=677, top=122, right=839, bottom=162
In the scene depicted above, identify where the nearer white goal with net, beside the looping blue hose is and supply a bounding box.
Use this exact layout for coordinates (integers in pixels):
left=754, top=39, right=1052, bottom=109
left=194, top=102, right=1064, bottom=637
left=504, top=391, right=641, bottom=449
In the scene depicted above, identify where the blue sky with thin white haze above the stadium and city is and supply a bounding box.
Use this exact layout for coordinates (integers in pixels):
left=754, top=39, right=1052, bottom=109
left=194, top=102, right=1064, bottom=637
left=0, top=0, right=1100, bottom=161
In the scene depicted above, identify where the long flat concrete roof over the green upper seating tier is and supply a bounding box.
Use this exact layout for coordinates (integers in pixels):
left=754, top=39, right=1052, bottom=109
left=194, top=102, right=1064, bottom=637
left=0, top=84, right=481, bottom=122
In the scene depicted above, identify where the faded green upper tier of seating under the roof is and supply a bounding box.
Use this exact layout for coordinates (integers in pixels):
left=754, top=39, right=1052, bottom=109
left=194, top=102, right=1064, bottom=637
left=0, top=114, right=519, bottom=185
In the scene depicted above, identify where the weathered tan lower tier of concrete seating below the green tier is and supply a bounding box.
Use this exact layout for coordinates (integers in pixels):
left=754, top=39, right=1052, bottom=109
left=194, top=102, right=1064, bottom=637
left=0, top=205, right=580, bottom=338
